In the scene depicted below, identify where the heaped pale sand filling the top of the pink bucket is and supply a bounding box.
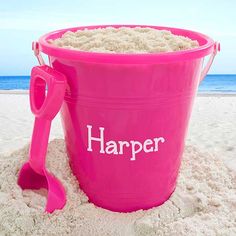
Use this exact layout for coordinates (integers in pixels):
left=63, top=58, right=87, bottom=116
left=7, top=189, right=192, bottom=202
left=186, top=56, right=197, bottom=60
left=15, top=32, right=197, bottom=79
left=49, top=27, right=199, bottom=53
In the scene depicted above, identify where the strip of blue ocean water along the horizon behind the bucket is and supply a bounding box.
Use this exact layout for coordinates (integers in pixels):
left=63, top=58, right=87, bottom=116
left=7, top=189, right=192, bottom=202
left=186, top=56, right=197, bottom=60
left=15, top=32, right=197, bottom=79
left=0, top=74, right=236, bottom=93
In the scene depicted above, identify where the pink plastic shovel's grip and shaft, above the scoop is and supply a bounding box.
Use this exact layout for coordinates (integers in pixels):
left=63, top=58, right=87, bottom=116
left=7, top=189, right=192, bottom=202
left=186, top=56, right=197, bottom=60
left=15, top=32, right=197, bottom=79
left=29, top=65, right=66, bottom=174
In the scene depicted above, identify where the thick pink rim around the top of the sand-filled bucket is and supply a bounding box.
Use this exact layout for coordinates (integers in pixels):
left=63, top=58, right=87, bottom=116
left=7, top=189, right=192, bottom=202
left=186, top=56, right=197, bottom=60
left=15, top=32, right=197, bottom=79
left=38, top=24, right=215, bottom=64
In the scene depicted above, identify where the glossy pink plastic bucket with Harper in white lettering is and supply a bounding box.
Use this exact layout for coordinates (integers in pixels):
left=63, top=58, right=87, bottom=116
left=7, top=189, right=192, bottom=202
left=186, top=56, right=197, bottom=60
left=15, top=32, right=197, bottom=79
left=30, top=25, right=219, bottom=212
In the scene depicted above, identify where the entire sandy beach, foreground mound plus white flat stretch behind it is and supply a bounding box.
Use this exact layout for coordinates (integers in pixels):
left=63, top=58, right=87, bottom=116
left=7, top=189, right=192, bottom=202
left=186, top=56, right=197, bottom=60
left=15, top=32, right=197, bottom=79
left=0, top=94, right=236, bottom=236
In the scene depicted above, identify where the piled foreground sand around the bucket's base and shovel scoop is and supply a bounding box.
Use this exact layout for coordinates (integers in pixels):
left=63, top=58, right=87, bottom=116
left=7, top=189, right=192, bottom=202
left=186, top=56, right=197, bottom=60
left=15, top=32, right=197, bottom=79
left=0, top=140, right=236, bottom=235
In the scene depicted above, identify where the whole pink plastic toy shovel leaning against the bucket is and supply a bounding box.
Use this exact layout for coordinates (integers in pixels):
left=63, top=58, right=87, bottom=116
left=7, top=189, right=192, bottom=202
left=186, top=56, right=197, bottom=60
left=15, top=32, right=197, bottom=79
left=18, top=65, right=66, bottom=213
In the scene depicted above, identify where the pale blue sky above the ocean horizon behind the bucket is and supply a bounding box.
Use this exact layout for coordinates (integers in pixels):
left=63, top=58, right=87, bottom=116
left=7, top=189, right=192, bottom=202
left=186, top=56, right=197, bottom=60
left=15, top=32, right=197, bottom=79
left=0, top=0, right=236, bottom=75
